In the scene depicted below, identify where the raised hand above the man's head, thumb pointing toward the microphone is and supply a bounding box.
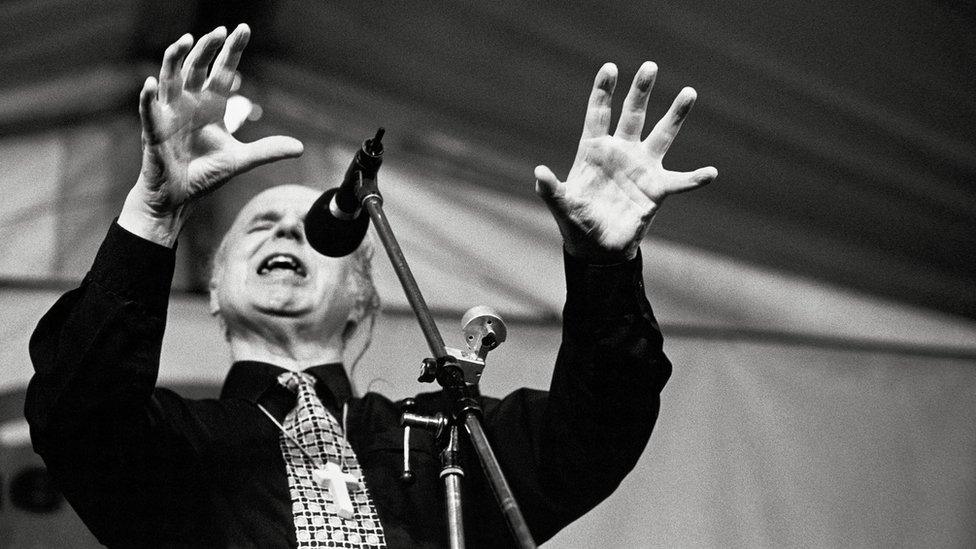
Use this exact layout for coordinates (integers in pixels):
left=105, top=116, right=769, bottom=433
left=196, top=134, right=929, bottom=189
left=119, top=25, right=302, bottom=246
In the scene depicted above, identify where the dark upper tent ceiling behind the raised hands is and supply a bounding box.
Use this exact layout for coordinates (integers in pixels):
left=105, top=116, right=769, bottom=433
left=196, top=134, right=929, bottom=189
left=0, top=0, right=976, bottom=318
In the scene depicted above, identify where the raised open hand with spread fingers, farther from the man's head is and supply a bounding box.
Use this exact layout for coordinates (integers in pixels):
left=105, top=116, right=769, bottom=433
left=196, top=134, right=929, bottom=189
left=535, top=61, right=718, bottom=263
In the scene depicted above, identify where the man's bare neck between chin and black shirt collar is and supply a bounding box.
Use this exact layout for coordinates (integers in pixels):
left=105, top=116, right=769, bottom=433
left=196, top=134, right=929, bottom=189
left=227, top=322, right=344, bottom=371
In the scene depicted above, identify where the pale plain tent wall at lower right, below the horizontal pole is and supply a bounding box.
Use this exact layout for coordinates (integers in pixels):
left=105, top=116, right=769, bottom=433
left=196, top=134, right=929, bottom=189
left=550, top=338, right=976, bottom=549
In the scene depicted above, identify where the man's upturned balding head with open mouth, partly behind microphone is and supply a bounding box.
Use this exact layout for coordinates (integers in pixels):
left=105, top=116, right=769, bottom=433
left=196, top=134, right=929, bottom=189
left=211, top=185, right=356, bottom=338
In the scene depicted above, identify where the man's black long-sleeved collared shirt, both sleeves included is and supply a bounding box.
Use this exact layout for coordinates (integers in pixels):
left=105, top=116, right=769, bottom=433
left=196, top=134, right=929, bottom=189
left=26, top=220, right=671, bottom=547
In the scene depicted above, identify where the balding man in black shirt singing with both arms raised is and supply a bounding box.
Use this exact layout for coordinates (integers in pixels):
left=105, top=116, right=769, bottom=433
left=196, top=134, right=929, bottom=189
left=26, top=25, right=716, bottom=547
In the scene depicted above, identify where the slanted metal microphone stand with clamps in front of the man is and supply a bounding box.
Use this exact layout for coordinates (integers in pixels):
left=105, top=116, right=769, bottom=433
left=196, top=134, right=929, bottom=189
left=356, top=128, right=536, bottom=549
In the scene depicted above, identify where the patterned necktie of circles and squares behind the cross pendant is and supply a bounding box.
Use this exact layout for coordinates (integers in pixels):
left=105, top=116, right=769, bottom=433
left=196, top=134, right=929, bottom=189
left=278, top=372, right=386, bottom=549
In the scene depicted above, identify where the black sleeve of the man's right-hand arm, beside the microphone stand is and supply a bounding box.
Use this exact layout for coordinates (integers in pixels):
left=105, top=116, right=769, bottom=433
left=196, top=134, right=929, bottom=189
left=485, top=249, right=671, bottom=542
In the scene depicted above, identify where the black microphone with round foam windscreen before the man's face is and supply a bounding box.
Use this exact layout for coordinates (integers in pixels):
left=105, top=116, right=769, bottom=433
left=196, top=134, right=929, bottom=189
left=305, top=128, right=386, bottom=257
